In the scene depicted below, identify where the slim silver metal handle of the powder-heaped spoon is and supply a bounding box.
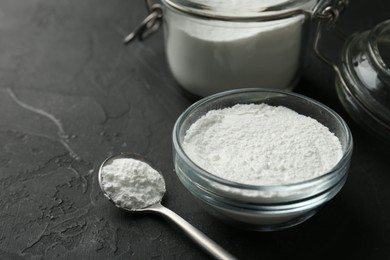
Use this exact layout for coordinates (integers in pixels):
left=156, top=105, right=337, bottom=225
left=150, top=204, right=236, bottom=260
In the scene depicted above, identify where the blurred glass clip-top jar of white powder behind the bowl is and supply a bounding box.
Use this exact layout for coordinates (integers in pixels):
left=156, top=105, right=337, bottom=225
left=125, top=0, right=347, bottom=97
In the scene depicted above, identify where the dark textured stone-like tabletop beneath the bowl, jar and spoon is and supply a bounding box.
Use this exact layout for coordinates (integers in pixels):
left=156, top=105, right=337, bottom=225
left=0, top=0, right=390, bottom=259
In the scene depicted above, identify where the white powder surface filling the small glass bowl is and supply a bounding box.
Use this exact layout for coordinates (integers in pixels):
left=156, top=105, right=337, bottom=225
left=183, top=104, right=342, bottom=185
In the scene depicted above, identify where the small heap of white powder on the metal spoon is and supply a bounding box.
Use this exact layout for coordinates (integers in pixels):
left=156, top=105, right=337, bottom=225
left=101, top=158, right=165, bottom=209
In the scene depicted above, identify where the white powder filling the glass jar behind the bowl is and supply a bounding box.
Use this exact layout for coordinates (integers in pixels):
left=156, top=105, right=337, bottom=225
left=164, top=5, right=305, bottom=96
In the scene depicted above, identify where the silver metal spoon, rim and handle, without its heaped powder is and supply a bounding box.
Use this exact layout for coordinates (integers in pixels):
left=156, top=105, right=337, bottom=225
left=98, top=154, right=236, bottom=259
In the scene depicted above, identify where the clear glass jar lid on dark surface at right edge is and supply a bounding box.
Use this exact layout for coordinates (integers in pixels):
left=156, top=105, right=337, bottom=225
left=337, top=20, right=390, bottom=141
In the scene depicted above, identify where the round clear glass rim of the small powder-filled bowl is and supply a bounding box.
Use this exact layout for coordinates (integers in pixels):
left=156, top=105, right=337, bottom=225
left=172, top=88, right=353, bottom=191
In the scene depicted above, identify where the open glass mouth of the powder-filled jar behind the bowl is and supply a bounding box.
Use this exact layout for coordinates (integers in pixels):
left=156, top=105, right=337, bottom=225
left=162, top=0, right=319, bottom=20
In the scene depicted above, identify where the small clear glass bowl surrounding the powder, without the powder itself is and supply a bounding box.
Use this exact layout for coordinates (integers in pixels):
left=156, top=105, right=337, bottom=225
left=173, top=89, right=353, bottom=231
